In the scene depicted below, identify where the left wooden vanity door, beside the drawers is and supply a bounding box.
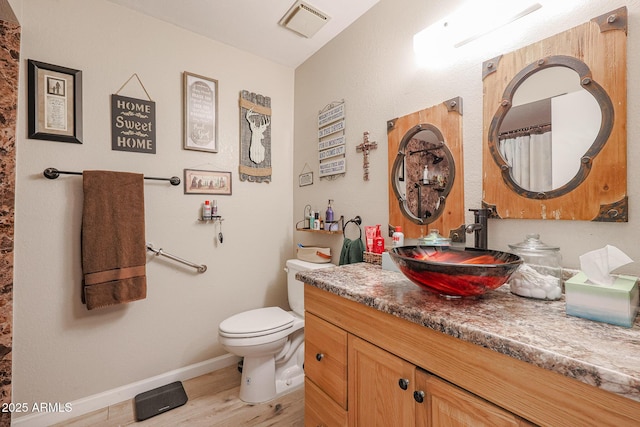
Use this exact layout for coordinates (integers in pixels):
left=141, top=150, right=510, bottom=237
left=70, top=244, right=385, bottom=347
left=347, top=335, right=415, bottom=427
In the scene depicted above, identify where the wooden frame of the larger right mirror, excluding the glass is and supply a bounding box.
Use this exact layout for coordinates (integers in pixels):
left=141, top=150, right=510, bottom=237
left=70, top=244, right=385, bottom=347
left=483, top=7, right=628, bottom=222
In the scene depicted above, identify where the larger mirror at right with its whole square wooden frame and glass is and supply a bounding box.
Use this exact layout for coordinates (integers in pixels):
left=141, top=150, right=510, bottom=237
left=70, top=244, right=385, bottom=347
left=483, top=8, right=627, bottom=221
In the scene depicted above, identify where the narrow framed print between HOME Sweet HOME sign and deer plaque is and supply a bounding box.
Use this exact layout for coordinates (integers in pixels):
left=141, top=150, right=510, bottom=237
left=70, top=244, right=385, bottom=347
left=183, top=71, right=218, bottom=153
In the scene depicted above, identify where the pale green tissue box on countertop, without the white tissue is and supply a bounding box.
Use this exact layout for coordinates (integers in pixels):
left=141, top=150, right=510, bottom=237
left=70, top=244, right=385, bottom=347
left=565, top=271, right=638, bottom=328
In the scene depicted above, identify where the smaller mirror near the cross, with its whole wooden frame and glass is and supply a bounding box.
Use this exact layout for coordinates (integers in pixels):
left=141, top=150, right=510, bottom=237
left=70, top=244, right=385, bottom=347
left=387, top=98, right=464, bottom=238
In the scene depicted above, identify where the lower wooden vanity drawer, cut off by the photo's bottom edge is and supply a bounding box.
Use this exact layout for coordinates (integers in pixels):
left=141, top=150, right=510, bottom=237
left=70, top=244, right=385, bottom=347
left=304, top=378, right=349, bottom=427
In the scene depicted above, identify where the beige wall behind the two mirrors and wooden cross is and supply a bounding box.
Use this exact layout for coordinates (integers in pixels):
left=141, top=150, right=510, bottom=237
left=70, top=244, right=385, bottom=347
left=293, top=0, right=640, bottom=274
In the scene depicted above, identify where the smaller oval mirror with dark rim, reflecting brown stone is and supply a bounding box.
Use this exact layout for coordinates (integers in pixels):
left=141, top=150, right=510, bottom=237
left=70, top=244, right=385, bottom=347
left=391, top=124, right=455, bottom=225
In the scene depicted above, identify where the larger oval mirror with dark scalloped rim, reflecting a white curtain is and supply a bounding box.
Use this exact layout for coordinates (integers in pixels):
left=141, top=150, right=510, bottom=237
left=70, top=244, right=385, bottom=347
left=489, top=55, right=613, bottom=199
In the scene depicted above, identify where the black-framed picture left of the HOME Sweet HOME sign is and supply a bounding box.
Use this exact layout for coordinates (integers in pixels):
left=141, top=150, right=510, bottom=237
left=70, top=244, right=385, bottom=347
left=27, top=59, right=82, bottom=144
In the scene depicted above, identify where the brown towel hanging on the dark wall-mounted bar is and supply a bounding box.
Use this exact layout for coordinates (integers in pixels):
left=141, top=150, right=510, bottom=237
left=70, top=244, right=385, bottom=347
left=82, top=171, right=147, bottom=310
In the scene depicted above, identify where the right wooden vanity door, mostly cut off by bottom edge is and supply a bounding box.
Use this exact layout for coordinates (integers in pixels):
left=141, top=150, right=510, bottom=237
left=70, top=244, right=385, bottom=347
left=416, top=370, right=529, bottom=427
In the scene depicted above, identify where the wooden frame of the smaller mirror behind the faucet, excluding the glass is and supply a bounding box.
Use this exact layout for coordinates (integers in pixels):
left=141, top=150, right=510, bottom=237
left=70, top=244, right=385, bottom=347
left=387, top=97, right=465, bottom=239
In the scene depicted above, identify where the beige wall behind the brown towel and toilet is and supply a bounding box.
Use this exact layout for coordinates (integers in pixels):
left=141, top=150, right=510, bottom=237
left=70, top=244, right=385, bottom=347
left=12, top=0, right=294, bottom=414
